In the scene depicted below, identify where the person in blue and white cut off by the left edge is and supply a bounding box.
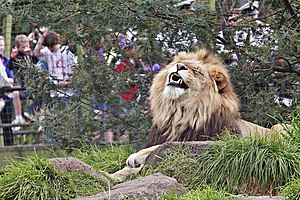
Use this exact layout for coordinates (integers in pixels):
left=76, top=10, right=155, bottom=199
left=0, top=36, right=14, bottom=146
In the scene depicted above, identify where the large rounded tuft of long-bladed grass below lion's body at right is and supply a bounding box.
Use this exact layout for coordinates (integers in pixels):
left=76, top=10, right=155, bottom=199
left=199, top=138, right=300, bottom=194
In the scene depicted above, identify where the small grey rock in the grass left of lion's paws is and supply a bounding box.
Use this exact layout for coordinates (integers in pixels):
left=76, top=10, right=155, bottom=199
left=49, top=157, right=112, bottom=186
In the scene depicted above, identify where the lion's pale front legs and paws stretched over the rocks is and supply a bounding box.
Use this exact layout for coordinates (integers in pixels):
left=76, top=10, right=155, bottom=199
left=110, top=145, right=160, bottom=181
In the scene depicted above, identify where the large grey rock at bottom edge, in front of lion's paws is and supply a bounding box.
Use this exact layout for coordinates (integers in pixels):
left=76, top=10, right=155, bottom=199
left=76, top=173, right=186, bottom=200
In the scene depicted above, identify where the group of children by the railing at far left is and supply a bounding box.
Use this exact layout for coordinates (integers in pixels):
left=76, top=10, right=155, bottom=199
left=0, top=28, right=77, bottom=146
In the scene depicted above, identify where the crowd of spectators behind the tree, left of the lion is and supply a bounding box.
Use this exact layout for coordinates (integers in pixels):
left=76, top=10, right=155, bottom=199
left=0, top=28, right=161, bottom=146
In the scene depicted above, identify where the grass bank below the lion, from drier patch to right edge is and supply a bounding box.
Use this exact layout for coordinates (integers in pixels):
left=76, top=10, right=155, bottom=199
left=154, top=127, right=300, bottom=195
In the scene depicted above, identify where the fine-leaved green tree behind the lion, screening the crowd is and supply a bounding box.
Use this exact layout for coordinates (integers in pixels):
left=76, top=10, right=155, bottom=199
left=0, top=0, right=300, bottom=146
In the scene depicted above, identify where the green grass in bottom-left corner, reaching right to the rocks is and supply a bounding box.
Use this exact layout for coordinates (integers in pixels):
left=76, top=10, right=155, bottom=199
left=0, top=155, right=108, bottom=200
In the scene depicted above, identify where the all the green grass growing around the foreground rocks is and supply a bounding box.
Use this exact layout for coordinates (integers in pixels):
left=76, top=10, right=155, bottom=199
left=0, top=109, right=300, bottom=200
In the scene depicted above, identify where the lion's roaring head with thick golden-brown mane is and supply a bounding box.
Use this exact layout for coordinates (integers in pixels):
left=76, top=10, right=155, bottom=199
left=146, top=49, right=240, bottom=146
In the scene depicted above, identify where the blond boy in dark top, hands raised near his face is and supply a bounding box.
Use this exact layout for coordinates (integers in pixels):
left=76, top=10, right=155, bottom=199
left=8, top=34, right=38, bottom=131
